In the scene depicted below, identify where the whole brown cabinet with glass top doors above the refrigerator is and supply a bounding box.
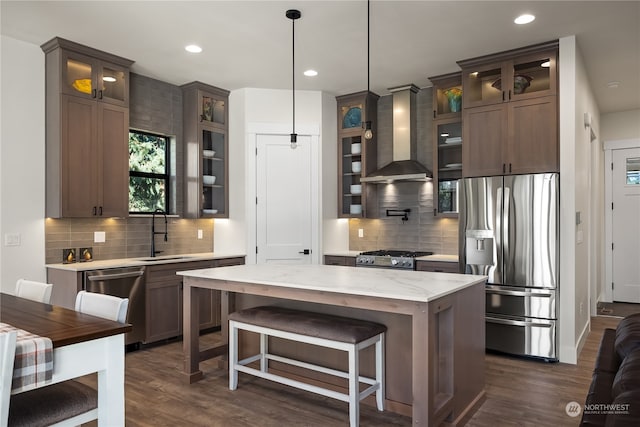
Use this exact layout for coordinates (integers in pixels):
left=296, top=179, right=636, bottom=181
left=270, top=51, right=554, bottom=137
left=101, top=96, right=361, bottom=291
left=458, top=42, right=559, bottom=177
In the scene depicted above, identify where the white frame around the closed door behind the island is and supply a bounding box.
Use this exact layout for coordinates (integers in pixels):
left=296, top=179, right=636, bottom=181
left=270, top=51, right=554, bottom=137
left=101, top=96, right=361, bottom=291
left=245, top=123, right=322, bottom=264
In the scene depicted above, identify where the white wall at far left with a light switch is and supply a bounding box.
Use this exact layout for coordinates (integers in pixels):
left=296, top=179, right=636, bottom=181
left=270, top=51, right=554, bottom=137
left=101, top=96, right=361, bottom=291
left=0, top=36, right=46, bottom=293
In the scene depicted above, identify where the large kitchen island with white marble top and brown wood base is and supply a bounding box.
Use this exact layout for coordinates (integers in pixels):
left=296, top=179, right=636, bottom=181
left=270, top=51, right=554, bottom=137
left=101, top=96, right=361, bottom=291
left=178, top=264, right=486, bottom=426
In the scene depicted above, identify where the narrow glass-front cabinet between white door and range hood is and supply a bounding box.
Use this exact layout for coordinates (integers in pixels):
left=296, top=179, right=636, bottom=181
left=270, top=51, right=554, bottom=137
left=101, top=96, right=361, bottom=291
left=336, top=91, right=379, bottom=218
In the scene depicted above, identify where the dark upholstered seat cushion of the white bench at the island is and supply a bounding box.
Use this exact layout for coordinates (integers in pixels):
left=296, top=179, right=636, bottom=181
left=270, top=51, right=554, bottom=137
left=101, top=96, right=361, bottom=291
left=229, top=306, right=387, bottom=344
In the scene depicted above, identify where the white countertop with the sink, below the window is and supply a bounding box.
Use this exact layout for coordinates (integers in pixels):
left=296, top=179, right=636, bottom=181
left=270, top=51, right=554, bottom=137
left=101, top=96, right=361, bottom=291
left=45, top=252, right=245, bottom=271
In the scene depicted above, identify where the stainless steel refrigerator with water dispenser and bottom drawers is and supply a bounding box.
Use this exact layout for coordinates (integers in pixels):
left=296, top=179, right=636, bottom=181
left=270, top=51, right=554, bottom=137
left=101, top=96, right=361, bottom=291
left=459, top=173, right=559, bottom=361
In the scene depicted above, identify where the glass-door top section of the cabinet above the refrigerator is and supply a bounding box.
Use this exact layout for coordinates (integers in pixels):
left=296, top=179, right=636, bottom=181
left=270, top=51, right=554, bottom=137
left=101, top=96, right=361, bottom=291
left=458, top=41, right=558, bottom=108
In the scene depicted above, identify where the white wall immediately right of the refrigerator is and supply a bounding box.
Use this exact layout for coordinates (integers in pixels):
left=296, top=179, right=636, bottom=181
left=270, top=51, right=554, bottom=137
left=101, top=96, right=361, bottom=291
left=558, top=36, right=604, bottom=363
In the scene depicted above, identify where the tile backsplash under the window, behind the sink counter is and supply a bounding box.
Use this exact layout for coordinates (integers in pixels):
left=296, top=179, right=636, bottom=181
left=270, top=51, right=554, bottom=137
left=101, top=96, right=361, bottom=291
left=45, top=216, right=214, bottom=264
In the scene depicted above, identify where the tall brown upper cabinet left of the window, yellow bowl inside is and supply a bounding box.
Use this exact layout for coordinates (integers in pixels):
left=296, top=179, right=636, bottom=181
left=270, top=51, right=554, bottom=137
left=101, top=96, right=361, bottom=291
left=42, top=38, right=133, bottom=218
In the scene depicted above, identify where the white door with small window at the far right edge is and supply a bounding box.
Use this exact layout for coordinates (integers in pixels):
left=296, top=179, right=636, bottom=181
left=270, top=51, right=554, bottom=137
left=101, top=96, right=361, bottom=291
left=611, top=148, right=640, bottom=303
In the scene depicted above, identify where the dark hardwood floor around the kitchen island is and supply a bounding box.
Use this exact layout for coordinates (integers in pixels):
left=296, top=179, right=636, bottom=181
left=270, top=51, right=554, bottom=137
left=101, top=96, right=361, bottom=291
left=82, top=317, right=620, bottom=427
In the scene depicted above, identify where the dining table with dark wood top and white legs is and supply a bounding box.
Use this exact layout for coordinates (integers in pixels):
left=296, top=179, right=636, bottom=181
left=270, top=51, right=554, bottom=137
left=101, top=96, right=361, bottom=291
left=0, top=293, right=131, bottom=426
